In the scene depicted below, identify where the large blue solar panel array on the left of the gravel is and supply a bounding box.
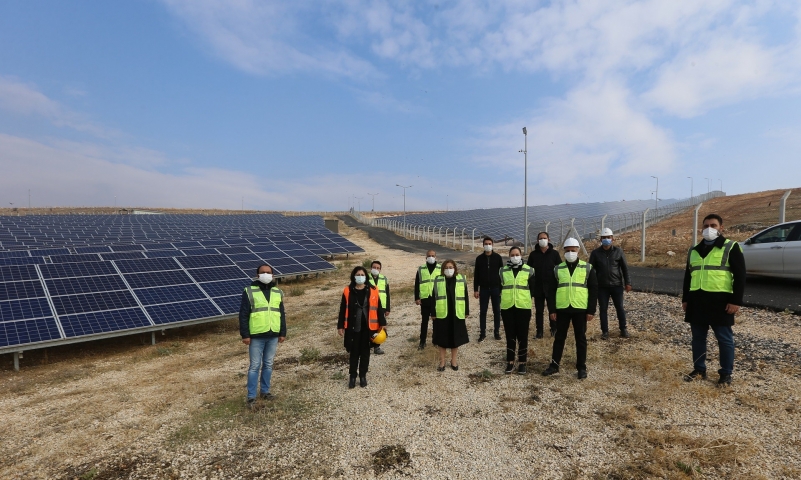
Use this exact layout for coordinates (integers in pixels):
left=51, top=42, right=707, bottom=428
left=0, top=215, right=362, bottom=352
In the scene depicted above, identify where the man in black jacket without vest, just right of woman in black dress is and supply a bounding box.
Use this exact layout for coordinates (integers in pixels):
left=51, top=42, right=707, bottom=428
left=473, top=237, right=503, bottom=342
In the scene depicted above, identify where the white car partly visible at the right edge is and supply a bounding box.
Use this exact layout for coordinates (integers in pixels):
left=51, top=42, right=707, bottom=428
left=740, top=221, right=801, bottom=279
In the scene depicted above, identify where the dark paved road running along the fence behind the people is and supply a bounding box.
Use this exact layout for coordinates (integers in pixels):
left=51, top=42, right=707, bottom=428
left=339, top=215, right=801, bottom=313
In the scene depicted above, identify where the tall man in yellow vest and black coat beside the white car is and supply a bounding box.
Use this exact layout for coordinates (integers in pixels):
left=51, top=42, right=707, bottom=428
left=681, top=213, right=745, bottom=386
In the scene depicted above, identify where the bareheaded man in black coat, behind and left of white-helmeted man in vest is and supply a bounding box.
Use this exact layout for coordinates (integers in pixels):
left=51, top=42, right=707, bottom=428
left=526, top=232, right=562, bottom=338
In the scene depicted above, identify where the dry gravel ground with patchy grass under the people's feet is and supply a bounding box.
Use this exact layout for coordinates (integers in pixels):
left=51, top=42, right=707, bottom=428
left=0, top=227, right=801, bottom=479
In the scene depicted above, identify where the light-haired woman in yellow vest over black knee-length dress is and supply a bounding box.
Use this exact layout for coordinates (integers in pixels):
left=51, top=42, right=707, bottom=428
left=429, top=260, right=470, bottom=372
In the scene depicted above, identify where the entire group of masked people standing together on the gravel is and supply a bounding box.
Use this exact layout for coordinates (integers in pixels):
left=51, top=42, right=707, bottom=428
left=239, top=214, right=745, bottom=406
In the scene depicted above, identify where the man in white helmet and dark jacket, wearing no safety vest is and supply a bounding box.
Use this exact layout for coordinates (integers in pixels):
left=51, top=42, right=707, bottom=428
left=589, top=228, right=631, bottom=340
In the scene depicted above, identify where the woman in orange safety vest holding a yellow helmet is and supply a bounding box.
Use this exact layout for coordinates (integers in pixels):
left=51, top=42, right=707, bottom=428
left=337, top=267, right=387, bottom=388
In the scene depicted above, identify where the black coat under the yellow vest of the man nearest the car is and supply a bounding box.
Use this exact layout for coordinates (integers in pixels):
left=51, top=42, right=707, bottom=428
left=681, top=235, right=745, bottom=326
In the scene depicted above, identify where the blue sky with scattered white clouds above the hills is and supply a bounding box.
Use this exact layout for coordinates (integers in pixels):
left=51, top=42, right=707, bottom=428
left=0, top=0, right=801, bottom=210
